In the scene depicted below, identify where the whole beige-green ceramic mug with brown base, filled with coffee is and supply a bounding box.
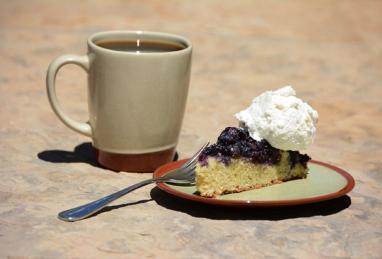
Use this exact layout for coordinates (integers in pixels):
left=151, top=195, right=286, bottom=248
left=46, top=31, right=192, bottom=172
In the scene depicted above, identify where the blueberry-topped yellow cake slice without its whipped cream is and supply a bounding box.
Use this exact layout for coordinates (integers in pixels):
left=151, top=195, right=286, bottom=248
left=196, top=127, right=310, bottom=197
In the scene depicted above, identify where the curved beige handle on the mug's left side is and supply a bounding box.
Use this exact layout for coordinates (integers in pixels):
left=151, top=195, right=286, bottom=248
left=46, top=55, right=92, bottom=137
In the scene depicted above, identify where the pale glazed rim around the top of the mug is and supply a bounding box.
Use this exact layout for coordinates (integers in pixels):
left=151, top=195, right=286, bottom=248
left=88, top=30, right=192, bottom=56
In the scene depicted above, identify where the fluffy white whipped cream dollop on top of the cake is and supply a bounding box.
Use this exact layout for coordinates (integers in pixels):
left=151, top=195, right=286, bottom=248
left=235, top=86, right=318, bottom=151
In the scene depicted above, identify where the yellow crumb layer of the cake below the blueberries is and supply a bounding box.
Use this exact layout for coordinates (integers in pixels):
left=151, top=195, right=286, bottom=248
left=196, top=151, right=308, bottom=197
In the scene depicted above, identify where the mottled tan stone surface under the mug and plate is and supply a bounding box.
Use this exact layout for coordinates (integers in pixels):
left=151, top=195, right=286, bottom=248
left=0, top=0, right=382, bottom=258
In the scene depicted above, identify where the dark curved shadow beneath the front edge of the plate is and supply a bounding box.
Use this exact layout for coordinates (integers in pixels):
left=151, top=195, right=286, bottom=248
left=150, top=187, right=351, bottom=221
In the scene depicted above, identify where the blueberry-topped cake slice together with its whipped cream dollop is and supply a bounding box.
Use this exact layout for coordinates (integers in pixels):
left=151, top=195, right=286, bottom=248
left=196, top=86, right=318, bottom=197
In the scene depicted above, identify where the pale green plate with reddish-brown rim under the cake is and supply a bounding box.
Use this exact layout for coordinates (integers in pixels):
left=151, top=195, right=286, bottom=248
left=154, top=159, right=354, bottom=207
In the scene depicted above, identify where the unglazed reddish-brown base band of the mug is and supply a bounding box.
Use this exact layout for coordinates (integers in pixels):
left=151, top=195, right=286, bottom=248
left=94, top=148, right=175, bottom=173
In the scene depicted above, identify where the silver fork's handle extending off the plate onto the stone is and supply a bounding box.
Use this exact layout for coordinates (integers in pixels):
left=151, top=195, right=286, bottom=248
left=58, top=179, right=155, bottom=221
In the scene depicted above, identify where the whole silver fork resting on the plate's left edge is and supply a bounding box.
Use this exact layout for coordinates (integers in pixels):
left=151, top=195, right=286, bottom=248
left=58, top=143, right=209, bottom=221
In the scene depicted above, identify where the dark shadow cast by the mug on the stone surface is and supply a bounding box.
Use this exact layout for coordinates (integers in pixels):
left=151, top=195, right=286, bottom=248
left=37, top=142, right=179, bottom=169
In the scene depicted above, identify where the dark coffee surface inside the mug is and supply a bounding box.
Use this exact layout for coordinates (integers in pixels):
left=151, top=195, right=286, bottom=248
left=96, top=40, right=185, bottom=53
